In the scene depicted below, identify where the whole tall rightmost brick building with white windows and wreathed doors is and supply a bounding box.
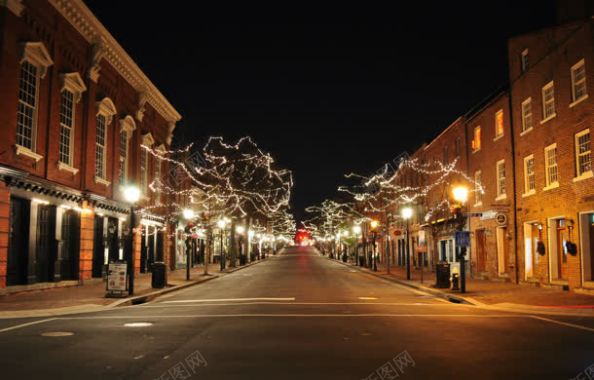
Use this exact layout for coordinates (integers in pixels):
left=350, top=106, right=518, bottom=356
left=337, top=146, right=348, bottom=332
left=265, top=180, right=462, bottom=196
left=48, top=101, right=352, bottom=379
left=508, top=18, right=594, bottom=289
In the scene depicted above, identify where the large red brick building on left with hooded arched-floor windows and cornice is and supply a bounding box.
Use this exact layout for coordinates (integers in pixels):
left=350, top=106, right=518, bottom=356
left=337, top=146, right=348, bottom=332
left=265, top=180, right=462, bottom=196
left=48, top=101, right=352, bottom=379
left=0, top=0, right=181, bottom=287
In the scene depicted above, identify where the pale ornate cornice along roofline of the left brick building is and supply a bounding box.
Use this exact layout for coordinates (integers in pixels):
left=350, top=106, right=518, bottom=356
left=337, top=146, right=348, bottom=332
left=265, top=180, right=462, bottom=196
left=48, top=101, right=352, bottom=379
left=49, top=0, right=181, bottom=131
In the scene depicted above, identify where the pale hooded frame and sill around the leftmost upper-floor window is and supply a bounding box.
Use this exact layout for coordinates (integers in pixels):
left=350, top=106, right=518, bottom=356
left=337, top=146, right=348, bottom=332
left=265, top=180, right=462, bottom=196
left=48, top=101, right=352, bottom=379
left=15, top=42, right=54, bottom=162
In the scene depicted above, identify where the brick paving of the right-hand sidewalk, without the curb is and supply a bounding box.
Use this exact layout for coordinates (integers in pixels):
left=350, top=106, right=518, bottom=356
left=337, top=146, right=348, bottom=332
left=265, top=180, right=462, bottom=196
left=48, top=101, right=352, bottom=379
left=336, top=262, right=594, bottom=308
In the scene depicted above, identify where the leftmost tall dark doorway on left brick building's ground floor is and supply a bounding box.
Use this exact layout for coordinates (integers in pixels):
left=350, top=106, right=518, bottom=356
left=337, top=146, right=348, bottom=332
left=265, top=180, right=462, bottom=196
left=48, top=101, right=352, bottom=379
left=6, top=197, right=30, bottom=286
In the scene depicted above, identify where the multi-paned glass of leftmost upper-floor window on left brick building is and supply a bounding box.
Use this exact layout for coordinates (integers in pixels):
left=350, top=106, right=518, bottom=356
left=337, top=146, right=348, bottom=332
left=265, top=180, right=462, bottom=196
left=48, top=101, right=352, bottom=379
left=17, top=61, right=39, bottom=150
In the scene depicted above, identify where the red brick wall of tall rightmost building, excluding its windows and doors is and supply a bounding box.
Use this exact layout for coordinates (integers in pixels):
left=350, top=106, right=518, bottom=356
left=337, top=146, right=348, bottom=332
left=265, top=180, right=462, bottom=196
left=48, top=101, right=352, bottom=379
left=508, top=22, right=594, bottom=288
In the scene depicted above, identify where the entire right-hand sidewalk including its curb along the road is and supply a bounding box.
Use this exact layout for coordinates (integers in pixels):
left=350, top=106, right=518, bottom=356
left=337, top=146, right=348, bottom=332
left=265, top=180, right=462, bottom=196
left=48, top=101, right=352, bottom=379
left=330, top=256, right=594, bottom=317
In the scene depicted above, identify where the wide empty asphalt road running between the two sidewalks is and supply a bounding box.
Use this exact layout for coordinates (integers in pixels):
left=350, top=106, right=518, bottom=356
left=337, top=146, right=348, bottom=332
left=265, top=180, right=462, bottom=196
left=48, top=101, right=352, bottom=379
left=0, top=248, right=594, bottom=380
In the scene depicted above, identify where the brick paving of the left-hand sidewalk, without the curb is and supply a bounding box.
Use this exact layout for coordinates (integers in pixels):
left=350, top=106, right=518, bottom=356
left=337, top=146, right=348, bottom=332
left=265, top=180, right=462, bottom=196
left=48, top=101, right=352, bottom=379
left=0, top=264, right=230, bottom=312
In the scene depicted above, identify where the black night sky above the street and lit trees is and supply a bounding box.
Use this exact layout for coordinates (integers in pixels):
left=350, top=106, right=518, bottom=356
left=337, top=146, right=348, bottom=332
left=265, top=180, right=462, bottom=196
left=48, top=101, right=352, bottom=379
left=86, top=0, right=555, bottom=221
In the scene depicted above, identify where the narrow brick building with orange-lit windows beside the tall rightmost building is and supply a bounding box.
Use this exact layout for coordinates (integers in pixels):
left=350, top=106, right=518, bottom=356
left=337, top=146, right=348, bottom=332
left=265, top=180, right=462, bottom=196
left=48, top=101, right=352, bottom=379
left=466, top=92, right=516, bottom=281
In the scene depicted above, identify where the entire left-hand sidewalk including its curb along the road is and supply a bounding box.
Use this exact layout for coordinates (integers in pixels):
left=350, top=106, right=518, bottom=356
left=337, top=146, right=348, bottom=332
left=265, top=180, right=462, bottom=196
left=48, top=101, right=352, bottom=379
left=0, top=260, right=262, bottom=318
